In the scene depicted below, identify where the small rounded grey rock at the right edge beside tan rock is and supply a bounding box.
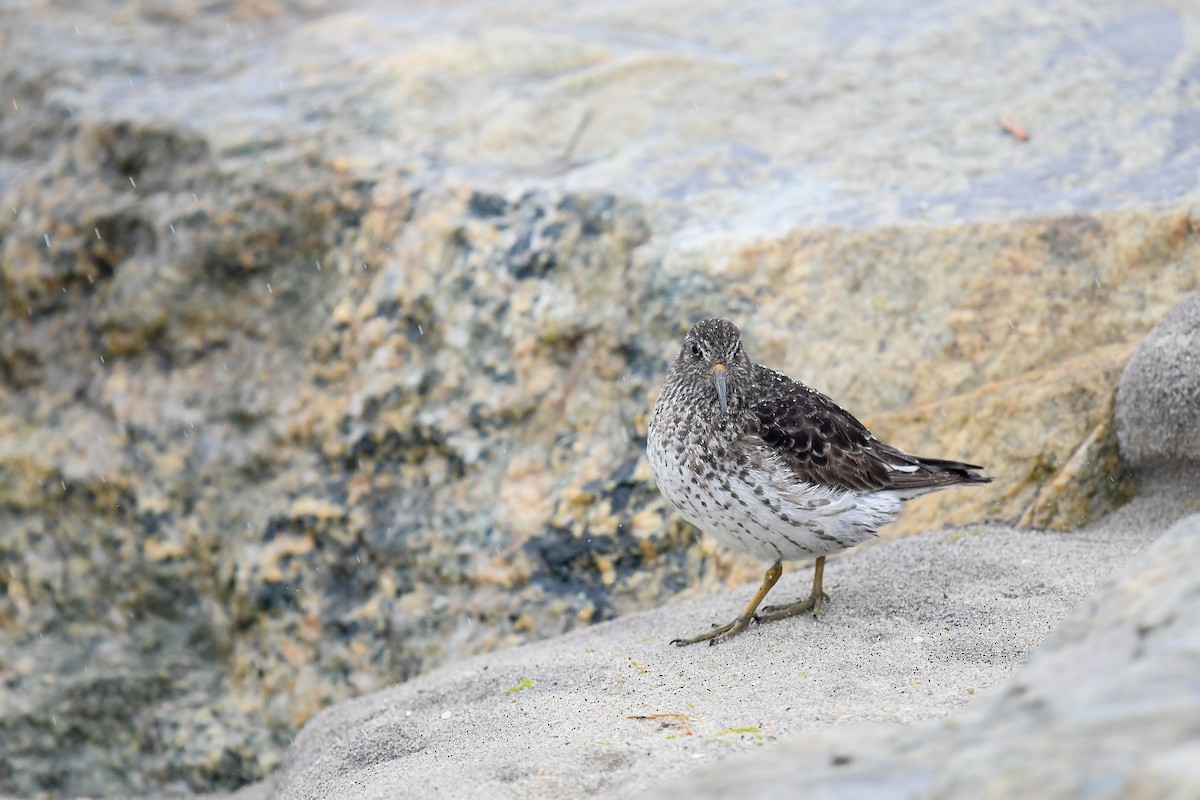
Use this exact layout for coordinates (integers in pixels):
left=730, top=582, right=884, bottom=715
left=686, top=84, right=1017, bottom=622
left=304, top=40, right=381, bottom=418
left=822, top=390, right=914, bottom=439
left=1116, top=294, right=1200, bottom=467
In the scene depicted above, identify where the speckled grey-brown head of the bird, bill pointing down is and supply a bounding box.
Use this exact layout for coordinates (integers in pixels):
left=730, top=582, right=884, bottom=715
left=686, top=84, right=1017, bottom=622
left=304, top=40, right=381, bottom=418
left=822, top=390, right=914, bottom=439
left=671, top=319, right=754, bottom=419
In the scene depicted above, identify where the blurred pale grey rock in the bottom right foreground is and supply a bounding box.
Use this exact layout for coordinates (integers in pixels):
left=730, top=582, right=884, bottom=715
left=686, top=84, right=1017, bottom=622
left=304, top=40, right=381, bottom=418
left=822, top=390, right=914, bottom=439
left=655, top=503, right=1200, bottom=799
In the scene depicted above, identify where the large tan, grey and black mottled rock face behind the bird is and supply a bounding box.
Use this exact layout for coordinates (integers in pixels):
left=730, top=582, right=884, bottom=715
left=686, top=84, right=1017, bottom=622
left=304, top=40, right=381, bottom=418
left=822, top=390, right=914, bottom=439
left=0, top=0, right=1200, bottom=795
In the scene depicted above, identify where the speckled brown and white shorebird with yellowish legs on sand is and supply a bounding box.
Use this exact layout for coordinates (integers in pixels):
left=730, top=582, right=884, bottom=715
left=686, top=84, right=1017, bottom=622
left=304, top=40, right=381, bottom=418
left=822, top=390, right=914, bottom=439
left=646, top=319, right=991, bottom=646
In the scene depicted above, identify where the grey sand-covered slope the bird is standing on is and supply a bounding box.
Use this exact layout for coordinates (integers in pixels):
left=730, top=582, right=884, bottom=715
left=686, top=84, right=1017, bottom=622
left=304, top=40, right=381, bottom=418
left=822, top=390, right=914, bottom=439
left=241, top=468, right=1198, bottom=799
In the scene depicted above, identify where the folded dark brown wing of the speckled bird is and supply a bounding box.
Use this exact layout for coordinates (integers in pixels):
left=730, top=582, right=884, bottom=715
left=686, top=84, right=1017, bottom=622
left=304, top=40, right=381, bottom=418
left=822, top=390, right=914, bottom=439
left=748, top=367, right=990, bottom=494
